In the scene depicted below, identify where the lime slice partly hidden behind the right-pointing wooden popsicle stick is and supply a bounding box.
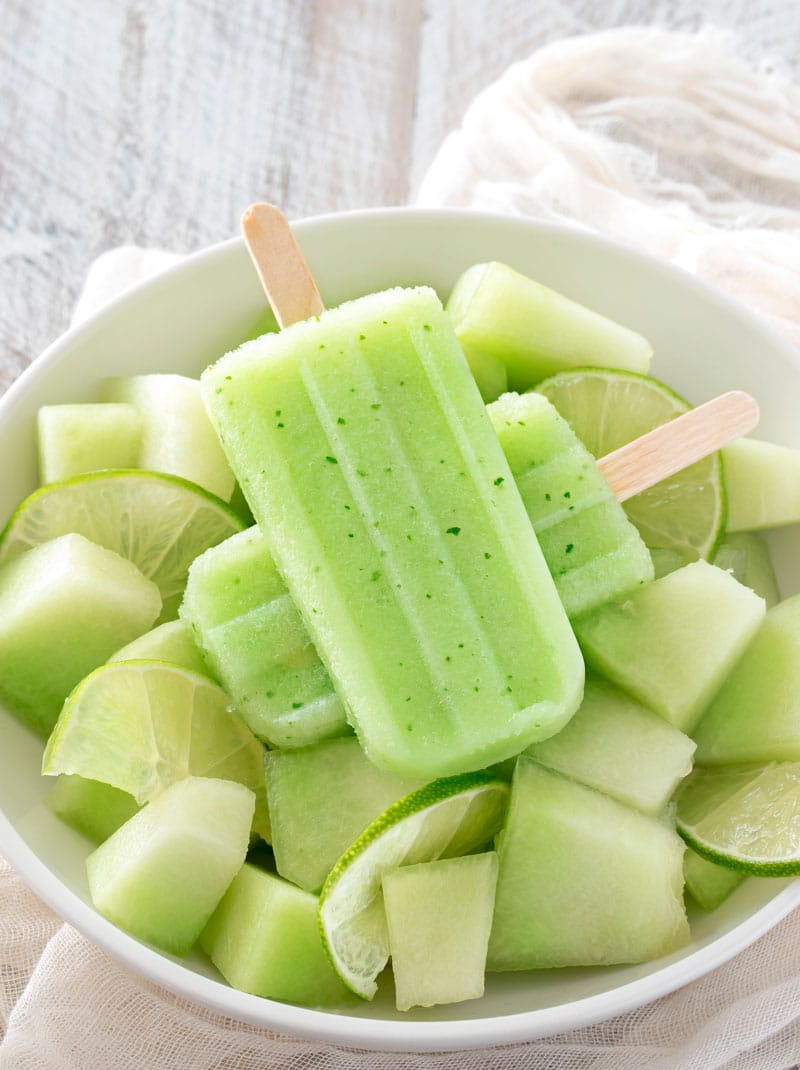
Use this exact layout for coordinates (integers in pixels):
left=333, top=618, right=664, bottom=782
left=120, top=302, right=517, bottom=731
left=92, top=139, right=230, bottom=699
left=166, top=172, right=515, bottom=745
left=537, top=368, right=726, bottom=564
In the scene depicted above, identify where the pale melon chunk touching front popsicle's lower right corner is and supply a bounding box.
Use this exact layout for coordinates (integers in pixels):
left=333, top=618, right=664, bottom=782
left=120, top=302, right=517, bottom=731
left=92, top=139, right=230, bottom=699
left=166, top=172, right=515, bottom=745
left=525, top=674, right=695, bottom=815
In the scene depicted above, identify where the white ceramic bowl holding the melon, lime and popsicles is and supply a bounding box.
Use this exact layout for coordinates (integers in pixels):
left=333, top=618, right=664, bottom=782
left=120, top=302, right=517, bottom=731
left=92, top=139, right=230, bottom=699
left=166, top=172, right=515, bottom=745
left=0, top=210, right=800, bottom=1051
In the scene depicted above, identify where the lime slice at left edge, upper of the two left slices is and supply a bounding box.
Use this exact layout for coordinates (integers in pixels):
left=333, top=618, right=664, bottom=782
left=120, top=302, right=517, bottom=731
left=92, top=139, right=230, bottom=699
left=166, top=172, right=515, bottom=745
left=0, top=469, right=244, bottom=621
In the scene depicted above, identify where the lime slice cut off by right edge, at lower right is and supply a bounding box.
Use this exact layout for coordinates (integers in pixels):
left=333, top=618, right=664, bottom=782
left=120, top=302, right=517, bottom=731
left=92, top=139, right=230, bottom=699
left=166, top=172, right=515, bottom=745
left=677, top=762, right=800, bottom=876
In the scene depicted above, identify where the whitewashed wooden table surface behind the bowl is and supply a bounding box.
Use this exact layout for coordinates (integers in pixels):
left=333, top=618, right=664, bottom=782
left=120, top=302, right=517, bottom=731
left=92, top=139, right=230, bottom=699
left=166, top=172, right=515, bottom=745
left=0, top=0, right=800, bottom=392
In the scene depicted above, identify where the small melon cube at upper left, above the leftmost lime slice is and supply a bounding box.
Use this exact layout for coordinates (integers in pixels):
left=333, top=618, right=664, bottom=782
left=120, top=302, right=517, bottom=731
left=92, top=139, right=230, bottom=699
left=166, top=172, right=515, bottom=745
left=36, top=402, right=141, bottom=483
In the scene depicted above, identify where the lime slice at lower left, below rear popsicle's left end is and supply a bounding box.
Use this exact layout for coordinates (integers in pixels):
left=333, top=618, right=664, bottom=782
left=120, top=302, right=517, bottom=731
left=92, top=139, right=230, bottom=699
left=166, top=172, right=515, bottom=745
left=42, top=661, right=268, bottom=838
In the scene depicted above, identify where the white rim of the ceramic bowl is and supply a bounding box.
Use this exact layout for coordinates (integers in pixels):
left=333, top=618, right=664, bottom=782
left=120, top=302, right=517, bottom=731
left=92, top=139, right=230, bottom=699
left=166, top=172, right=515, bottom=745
left=0, top=207, right=800, bottom=1053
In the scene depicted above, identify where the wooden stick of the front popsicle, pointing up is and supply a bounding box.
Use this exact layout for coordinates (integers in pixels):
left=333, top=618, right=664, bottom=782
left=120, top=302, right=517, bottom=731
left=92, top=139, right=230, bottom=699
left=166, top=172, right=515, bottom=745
left=242, top=204, right=325, bottom=327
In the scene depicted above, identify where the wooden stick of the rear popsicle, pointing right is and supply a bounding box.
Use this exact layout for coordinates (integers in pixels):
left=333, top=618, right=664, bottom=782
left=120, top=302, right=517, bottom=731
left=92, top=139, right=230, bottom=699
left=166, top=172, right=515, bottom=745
left=597, top=391, right=759, bottom=502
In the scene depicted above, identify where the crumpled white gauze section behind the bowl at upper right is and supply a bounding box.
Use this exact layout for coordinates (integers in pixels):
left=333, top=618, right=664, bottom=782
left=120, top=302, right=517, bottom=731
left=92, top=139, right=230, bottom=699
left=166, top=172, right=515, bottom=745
left=417, top=27, right=800, bottom=345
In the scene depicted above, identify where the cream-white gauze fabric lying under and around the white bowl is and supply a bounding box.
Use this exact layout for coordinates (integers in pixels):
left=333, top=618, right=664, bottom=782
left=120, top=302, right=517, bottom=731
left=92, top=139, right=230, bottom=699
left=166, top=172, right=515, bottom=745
left=0, top=23, right=800, bottom=1070
